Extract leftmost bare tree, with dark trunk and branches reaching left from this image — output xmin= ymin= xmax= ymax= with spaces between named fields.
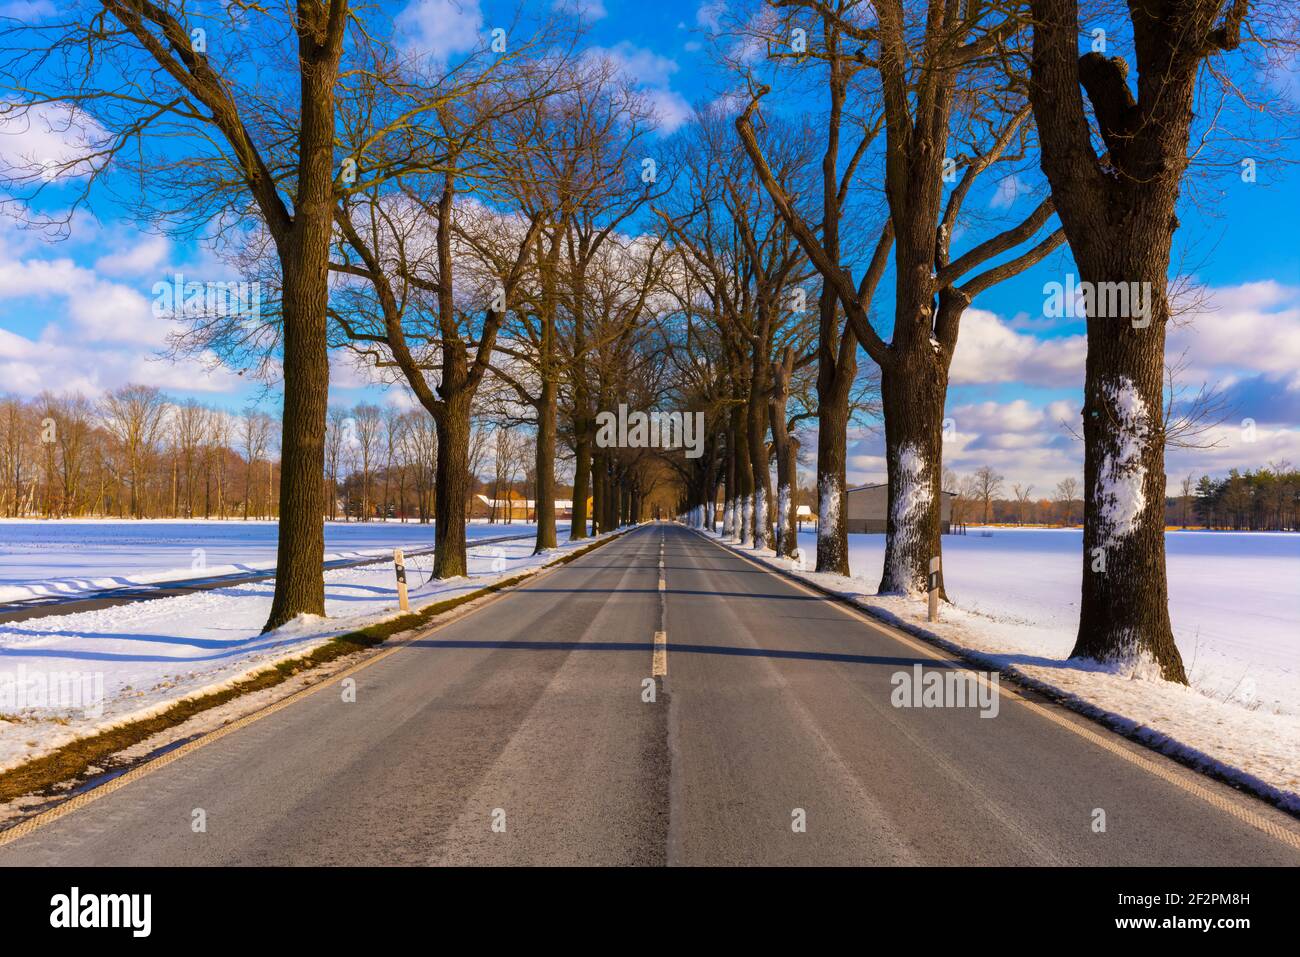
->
xmin=0 ymin=0 xmax=373 ymax=629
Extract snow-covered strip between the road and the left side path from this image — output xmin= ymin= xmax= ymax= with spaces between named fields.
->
xmin=0 ymin=523 xmax=588 ymax=770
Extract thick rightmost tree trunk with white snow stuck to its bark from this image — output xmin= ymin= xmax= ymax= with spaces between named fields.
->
xmin=1030 ymin=0 xmax=1216 ymax=684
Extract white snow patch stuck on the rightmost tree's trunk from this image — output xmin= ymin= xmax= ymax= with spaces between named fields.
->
xmin=1095 ymin=376 xmax=1151 ymax=547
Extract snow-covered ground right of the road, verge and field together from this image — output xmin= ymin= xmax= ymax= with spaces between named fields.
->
xmin=728 ymin=528 xmax=1300 ymax=810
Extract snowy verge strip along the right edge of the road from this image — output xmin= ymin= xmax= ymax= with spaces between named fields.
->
xmin=696 ymin=529 xmax=1300 ymax=814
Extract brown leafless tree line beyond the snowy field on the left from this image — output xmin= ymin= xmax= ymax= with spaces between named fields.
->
xmin=0 ymin=385 xmax=572 ymax=523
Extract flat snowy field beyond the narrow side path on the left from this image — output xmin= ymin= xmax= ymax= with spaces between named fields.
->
xmin=0 ymin=520 xmax=556 ymax=602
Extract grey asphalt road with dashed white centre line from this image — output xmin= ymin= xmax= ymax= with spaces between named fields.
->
xmin=0 ymin=524 xmax=1300 ymax=866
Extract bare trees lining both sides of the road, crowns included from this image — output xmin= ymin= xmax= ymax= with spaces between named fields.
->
xmin=0 ymin=0 xmax=1296 ymax=681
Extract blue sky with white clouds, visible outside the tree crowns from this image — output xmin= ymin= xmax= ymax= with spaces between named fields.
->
xmin=0 ymin=0 xmax=1300 ymax=494
